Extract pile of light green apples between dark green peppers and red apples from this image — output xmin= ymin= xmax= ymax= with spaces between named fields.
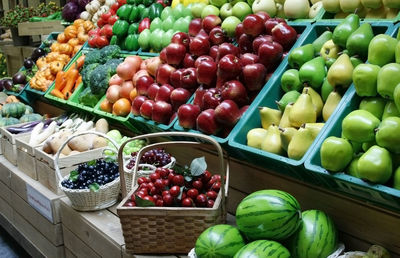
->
xmin=138 ymin=4 xmax=192 ymax=52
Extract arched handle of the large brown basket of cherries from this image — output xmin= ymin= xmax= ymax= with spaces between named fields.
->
xmin=118 ymin=132 xmax=229 ymax=203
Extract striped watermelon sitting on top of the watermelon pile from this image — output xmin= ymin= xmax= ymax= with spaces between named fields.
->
xmin=236 ymin=190 xmax=301 ymax=240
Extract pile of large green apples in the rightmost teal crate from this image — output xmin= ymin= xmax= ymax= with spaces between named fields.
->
xmin=320 ymin=28 xmax=400 ymax=189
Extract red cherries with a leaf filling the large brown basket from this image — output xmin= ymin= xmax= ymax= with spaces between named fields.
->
xmin=124 ymin=155 xmax=222 ymax=208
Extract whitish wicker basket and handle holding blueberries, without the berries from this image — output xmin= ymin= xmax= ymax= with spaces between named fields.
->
xmin=55 ymin=131 xmax=120 ymax=211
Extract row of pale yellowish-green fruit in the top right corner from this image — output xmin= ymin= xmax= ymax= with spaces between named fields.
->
xmin=322 ymin=0 xmax=400 ymax=19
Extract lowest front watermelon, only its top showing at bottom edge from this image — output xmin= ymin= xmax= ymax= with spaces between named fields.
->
xmin=234 ymin=240 xmax=290 ymax=258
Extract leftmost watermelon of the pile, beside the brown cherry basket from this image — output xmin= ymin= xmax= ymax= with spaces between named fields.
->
xmin=195 ymin=224 xmax=245 ymax=258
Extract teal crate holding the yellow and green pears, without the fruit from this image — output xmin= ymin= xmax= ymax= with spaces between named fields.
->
xmin=229 ymin=23 xmax=392 ymax=184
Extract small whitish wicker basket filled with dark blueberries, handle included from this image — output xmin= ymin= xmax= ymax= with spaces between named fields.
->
xmin=55 ymin=131 xmax=120 ymax=211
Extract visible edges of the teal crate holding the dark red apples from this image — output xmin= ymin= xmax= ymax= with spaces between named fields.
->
xmin=174 ymin=23 xmax=311 ymax=147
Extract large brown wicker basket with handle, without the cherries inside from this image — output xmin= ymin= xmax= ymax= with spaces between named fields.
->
xmin=117 ymin=132 xmax=229 ymax=254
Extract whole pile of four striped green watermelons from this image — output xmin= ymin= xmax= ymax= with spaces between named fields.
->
xmin=194 ymin=190 xmax=338 ymax=258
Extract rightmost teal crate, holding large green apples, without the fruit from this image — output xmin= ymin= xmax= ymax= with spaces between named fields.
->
xmin=305 ymin=86 xmax=400 ymax=211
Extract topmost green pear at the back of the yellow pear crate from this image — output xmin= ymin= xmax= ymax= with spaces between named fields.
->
xmin=332 ymin=13 xmax=360 ymax=48
